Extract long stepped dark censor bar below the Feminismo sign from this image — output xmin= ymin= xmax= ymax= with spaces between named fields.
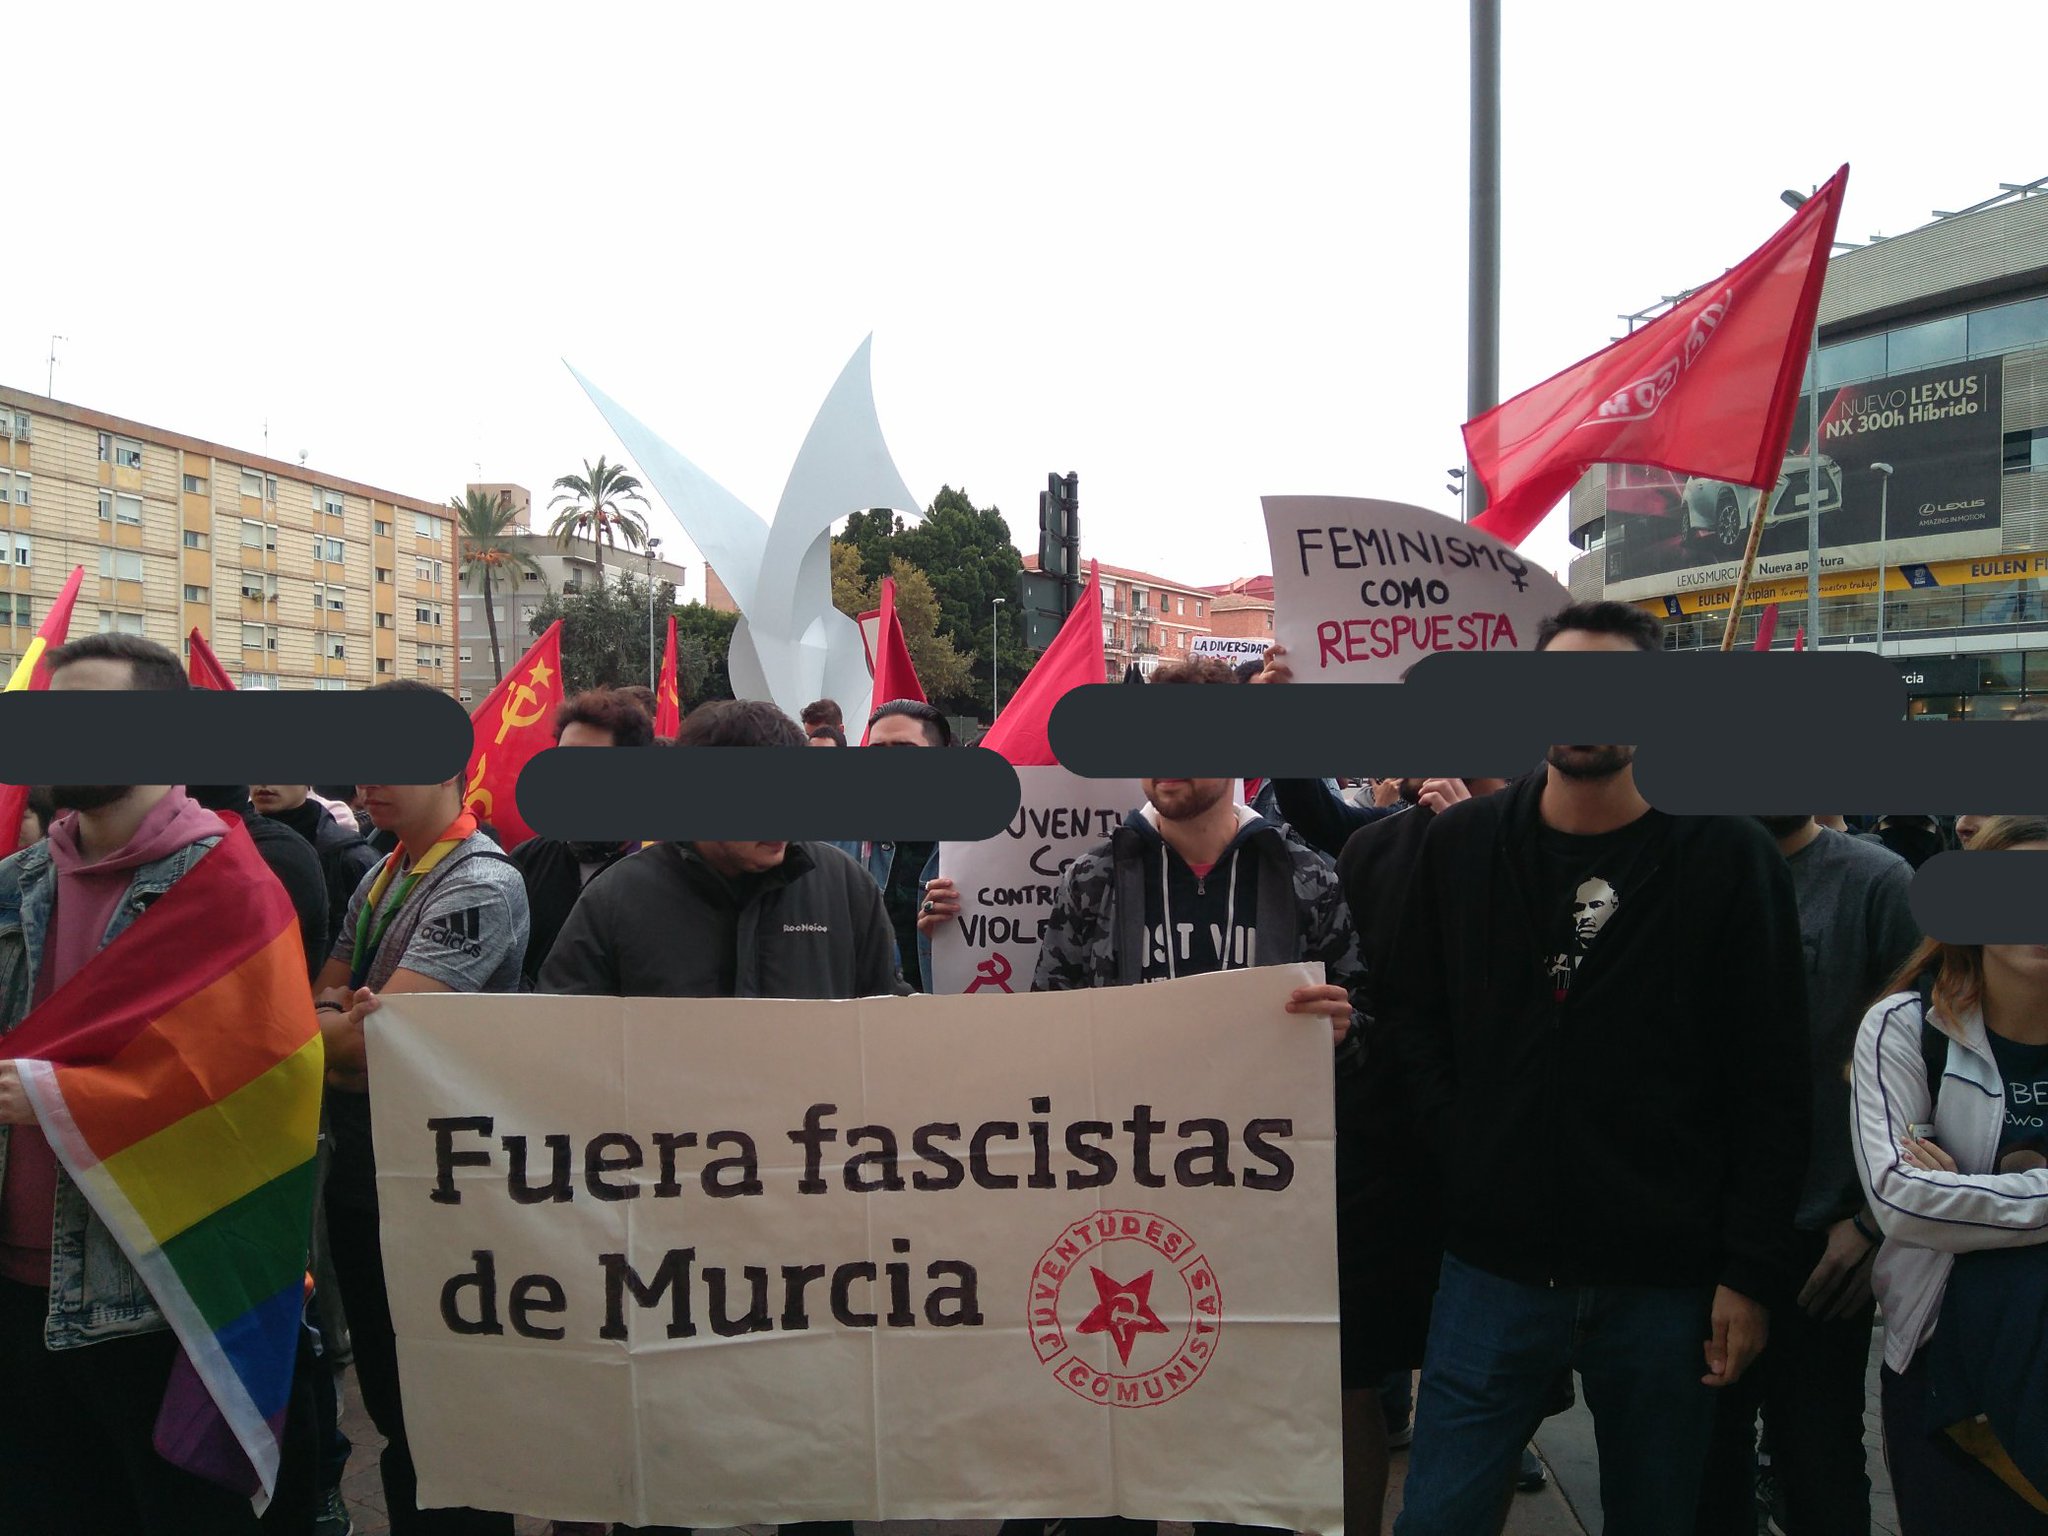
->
xmin=1051 ymin=651 xmax=2048 ymax=815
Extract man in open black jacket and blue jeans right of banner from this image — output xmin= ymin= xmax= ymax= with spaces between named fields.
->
xmin=1376 ymin=602 xmax=1812 ymax=1536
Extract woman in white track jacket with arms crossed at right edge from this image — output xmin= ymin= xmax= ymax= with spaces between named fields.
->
xmin=1851 ymin=817 xmax=2048 ymax=1536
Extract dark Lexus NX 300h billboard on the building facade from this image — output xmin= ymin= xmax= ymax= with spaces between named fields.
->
xmin=1606 ymin=358 xmax=2001 ymax=600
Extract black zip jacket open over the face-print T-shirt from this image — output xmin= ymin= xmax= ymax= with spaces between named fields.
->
xmin=1376 ymin=774 xmax=1810 ymax=1305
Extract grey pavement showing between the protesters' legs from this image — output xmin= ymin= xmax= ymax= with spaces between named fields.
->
xmin=342 ymin=1335 xmax=1898 ymax=1536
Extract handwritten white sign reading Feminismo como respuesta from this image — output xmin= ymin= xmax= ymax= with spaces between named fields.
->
xmin=1264 ymin=496 xmax=1571 ymax=682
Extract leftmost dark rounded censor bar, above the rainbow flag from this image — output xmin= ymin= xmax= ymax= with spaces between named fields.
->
xmin=0 ymin=688 xmax=473 ymax=784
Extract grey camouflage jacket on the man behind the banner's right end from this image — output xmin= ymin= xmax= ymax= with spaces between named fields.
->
xmin=1032 ymin=807 xmax=1364 ymax=1061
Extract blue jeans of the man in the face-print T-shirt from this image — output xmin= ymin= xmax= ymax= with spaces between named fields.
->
xmin=1395 ymin=1253 xmax=1714 ymax=1536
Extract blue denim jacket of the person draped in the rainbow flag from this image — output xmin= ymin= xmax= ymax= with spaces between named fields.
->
xmin=0 ymin=838 xmax=219 ymax=1350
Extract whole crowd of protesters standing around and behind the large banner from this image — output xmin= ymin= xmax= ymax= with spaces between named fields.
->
xmin=0 ymin=604 xmax=2048 ymax=1536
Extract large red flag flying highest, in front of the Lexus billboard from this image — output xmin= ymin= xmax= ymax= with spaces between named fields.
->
xmin=1464 ymin=166 xmax=1849 ymax=545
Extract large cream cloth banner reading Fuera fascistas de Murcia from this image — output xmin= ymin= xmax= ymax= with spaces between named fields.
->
xmin=369 ymin=965 xmax=1343 ymax=1532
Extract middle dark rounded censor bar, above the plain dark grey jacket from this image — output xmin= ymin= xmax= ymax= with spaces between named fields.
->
xmin=518 ymin=745 xmax=1019 ymax=842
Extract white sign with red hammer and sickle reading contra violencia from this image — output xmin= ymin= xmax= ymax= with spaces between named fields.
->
xmin=932 ymin=768 xmax=1145 ymax=993
